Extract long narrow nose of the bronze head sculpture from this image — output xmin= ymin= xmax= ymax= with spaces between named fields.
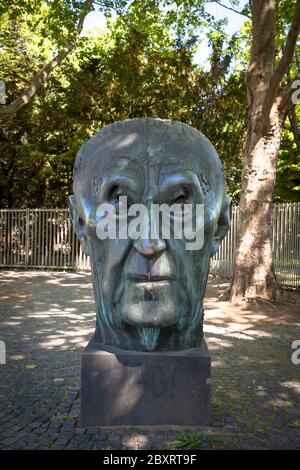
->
xmin=133 ymin=203 xmax=166 ymax=258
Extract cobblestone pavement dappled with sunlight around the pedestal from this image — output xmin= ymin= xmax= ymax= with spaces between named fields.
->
xmin=0 ymin=271 xmax=300 ymax=449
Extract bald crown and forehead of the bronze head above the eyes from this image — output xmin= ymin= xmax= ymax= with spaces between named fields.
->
xmin=74 ymin=118 xmax=226 ymax=212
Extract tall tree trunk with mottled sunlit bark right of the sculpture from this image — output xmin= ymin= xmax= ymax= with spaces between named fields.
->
xmin=229 ymin=0 xmax=300 ymax=302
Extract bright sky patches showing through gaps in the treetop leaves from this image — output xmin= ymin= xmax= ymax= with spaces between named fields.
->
xmin=83 ymin=0 xmax=247 ymax=67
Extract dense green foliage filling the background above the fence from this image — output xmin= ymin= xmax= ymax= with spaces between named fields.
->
xmin=0 ymin=0 xmax=300 ymax=207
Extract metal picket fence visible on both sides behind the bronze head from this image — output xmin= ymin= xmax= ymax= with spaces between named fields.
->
xmin=0 ymin=203 xmax=300 ymax=286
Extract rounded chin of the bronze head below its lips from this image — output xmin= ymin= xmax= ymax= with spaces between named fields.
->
xmin=121 ymin=281 xmax=176 ymax=328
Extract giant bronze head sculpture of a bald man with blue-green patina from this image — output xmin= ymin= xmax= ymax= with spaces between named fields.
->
xmin=71 ymin=119 xmax=230 ymax=350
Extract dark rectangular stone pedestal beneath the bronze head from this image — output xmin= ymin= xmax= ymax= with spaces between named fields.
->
xmin=81 ymin=339 xmax=211 ymax=427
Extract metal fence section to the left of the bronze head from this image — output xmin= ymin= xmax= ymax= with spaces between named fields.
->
xmin=0 ymin=209 xmax=89 ymax=270
